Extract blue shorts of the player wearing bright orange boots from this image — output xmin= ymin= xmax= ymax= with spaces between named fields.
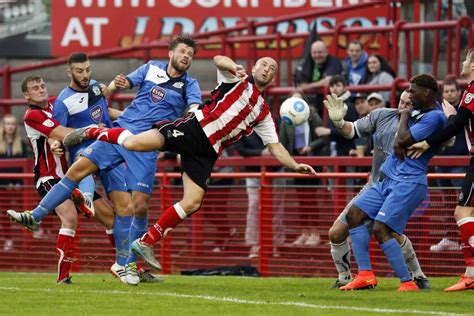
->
xmin=354 ymin=178 xmax=428 ymax=235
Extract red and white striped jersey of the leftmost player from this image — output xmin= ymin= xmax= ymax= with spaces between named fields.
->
xmin=23 ymin=104 xmax=67 ymax=186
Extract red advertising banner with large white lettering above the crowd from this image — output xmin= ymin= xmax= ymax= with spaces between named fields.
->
xmin=51 ymin=0 xmax=386 ymax=57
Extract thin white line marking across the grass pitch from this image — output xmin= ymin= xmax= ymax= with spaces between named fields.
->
xmin=0 ymin=286 xmax=467 ymax=316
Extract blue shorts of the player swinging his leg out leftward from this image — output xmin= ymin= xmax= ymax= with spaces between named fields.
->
xmin=82 ymin=141 xmax=158 ymax=194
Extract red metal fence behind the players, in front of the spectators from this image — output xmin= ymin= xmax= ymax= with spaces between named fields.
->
xmin=0 ymin=157 xmax=467 ymax=276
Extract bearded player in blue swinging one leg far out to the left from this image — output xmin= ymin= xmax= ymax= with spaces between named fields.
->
xmin=6 ymin=35 xmax=202 ymax=285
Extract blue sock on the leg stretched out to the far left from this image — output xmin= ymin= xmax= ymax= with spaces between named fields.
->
xmin=33 ymin=177 xmax=77 ymax=223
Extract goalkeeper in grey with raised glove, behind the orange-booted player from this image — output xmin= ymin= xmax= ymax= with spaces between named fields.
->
xmin=324 ymin=91 xmax=430 ymax=289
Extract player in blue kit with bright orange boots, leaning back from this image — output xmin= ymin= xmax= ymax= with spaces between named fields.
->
xmin=327 ymin=74 xmax=446 ymax=291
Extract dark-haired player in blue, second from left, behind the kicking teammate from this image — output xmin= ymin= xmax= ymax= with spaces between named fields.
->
xmin=53 ymin=52 xmax=141 ymax=282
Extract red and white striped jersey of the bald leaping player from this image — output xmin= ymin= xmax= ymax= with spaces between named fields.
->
xmin=195 ymin=71 xmax=279 ymax=155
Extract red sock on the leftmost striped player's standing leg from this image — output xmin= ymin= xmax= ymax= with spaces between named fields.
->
xmin=56 ymin=229 xmax=75 ymax=283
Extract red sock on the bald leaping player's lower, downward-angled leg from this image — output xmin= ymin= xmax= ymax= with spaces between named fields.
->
xmin=140 ymin=203 xmax=186 ymax=245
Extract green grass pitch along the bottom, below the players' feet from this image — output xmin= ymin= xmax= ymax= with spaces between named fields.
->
xmin=0 ymin=272 xmax=474 ymax=316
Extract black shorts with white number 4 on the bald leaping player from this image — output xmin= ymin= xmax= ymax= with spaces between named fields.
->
xmin=155 ymin=113 xmax=217 ymax=190
